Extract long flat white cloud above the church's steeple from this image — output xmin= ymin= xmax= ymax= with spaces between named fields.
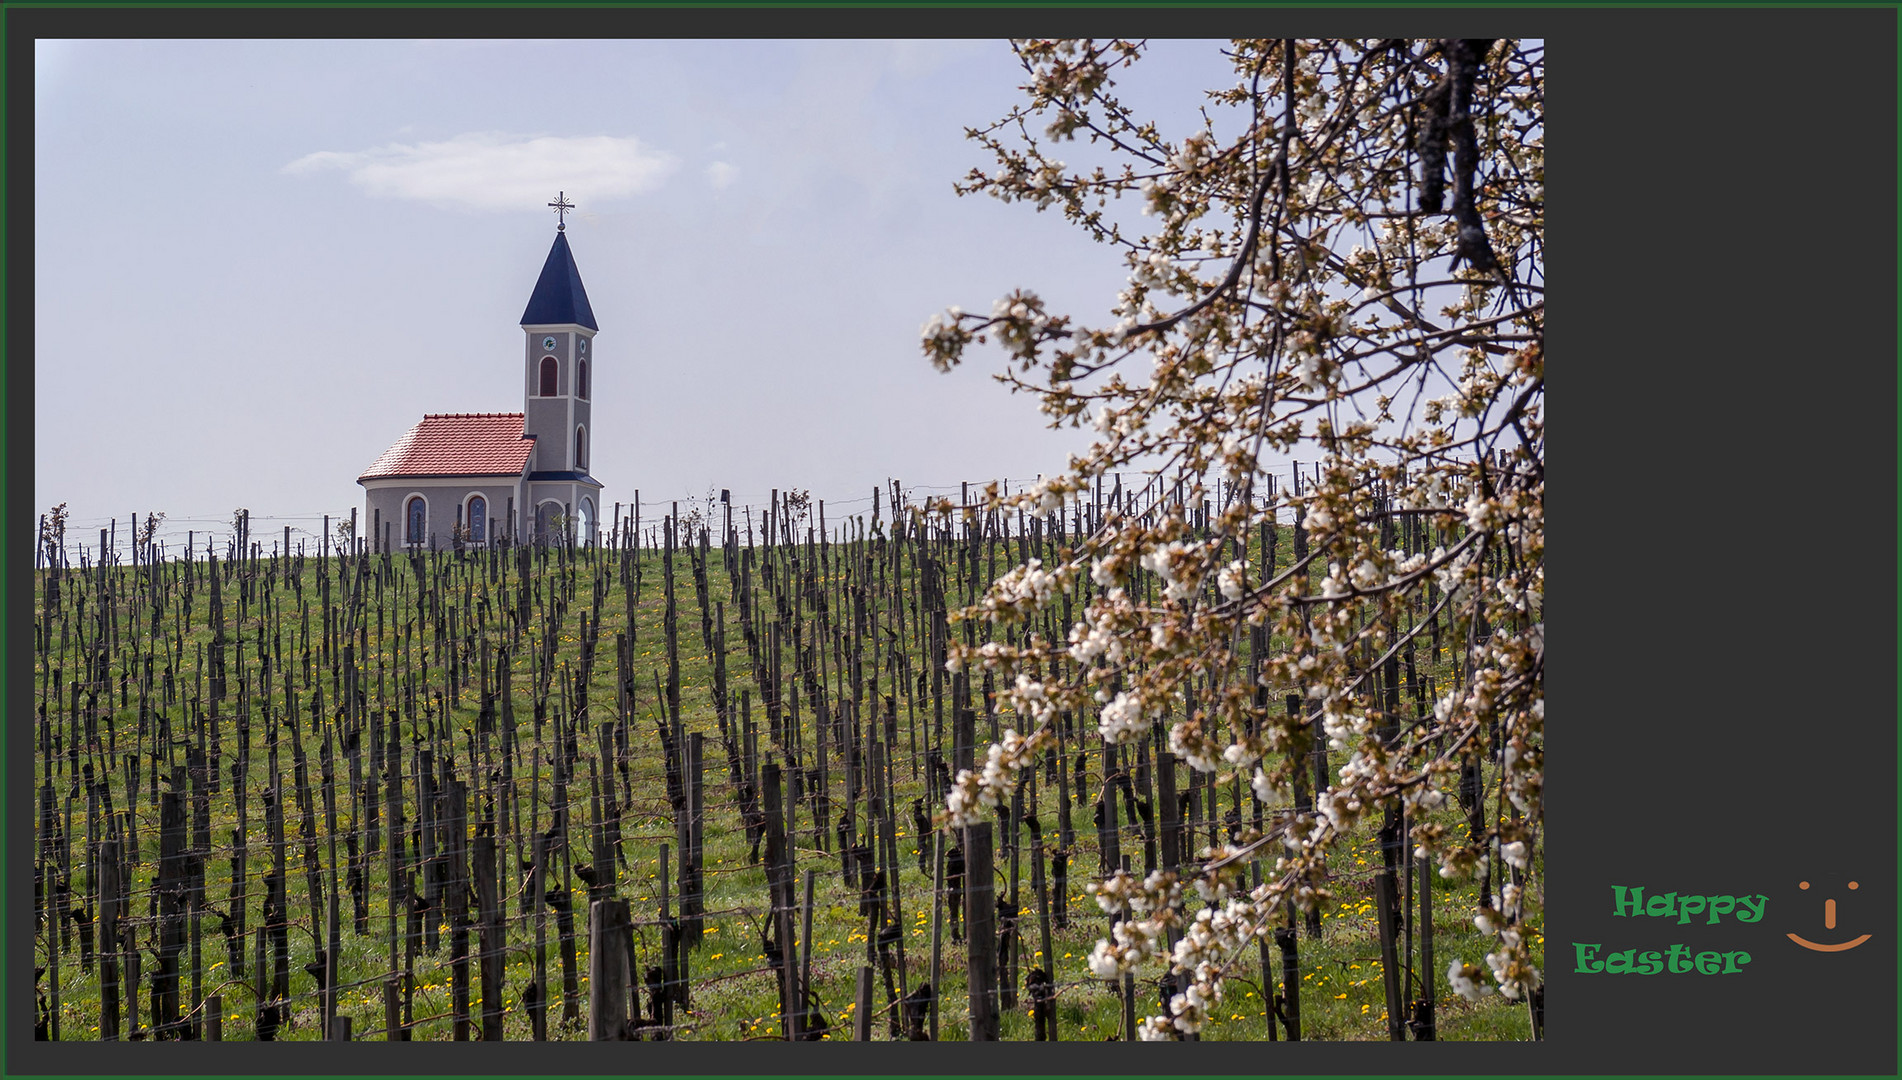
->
xmin=283 ymin=131 xmax=677 ymax=209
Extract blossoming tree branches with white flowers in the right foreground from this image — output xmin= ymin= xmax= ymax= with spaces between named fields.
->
xmin=922 ymin=38 xmax=1544 ymax=1038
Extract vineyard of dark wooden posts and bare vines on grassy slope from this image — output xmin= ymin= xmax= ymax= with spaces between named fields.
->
xmin=32 ymin=472 xmax=1543 ymax=1040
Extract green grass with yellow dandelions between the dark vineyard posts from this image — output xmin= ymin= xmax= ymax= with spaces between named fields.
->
xmin=34 ymin=517 xmax=1543 ymax=1040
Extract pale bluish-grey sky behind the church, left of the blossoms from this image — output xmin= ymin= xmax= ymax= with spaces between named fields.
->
xmin=34 ymin=40 xmax=1255 ymax=551
